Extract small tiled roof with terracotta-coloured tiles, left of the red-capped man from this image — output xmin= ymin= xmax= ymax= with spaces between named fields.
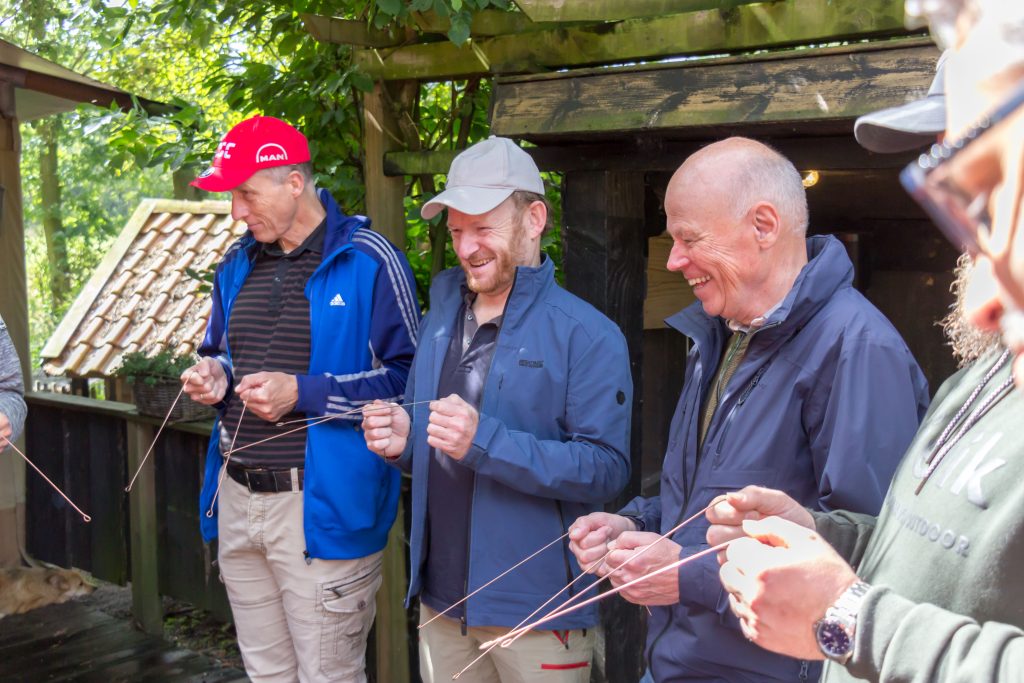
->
xmin=42 ymin=199 xmax=246 ymax=378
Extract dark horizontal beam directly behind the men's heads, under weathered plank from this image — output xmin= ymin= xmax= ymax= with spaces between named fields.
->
xmin=384 ymin=137 xmax=918 ymax=176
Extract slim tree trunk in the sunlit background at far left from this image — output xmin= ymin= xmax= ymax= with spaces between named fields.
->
xmin=36 ymin=116 xmax=71 ymax=311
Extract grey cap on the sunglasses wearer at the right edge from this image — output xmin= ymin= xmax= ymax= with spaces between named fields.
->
xmin=853 ymin=52 xmax=948 ymax=153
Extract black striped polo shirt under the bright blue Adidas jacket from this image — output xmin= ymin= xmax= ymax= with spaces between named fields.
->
xmin=221 ymin=219 xmax=327 ymax=469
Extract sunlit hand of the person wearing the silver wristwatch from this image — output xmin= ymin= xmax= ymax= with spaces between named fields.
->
xmin=719 ymin=517 xmax=857 ymax=659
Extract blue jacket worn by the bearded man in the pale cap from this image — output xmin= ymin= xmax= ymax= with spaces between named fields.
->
xmin=398 ymin=257 xmax=633 ymax=630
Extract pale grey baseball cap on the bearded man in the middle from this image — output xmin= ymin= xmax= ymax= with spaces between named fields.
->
xmin=420 ymin=135 xmax=544 ymax=220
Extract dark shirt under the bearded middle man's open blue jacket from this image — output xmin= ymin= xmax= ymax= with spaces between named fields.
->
xmin=421 ymin=288 xmax=503 ymax=618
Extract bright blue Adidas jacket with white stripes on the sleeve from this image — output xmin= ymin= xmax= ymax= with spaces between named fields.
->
xmin=200 ymin=189 xmax=420 ymax=559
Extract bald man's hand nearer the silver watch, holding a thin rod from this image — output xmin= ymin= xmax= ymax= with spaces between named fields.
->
xmin=599 ymin=531 xmax=682 ymax=605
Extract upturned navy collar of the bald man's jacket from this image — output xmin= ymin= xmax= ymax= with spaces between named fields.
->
xmin=665 ymin=234 xmax=853 ymax=354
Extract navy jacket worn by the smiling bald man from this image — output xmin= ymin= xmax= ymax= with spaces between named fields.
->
xmin=623 ymin=237 xmax=928 ymax=683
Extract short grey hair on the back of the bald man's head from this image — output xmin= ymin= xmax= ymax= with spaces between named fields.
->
xmin=733 ymin=142 xmax=809 ymax=237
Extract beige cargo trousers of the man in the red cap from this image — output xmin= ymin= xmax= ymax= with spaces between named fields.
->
xmin=217 ymin=476 xmax=381 ymax=683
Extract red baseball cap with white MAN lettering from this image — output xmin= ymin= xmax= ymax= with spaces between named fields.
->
xmin=191 ymin=116 xmax=309 ymax=193
